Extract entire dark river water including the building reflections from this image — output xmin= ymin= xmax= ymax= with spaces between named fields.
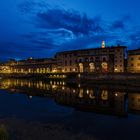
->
xmin=0 ymin=79 xmax=140 ymax=140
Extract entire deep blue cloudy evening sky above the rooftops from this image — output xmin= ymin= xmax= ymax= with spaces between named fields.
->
xmin=0 ymin=0 xmax=140 ymax=60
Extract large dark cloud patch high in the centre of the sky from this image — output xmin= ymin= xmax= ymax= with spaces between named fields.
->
xmin=37 ymin=9 xmax=103 ymax=35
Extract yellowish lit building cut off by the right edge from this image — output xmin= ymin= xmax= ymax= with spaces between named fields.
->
xmin=128 ymin=49 xmax=140 ymax=73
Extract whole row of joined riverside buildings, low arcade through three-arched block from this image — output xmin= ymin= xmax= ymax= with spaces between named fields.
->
xmin=0 ymin=41 xmax=126 ymax=74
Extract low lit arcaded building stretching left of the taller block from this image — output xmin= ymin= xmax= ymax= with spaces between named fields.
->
xmin=0 ymin=58 xmax=57 ymax=74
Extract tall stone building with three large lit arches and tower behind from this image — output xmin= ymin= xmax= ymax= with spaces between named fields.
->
xmin=55 ymin=42 xmax=126 ymax=72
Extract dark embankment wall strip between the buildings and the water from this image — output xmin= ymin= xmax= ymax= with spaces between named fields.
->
xmin=0 ymin=73 xmax=140 ymax=87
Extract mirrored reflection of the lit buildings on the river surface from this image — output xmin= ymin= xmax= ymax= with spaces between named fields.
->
xmin=0 ymin=79 xmax=140 ymax=116
